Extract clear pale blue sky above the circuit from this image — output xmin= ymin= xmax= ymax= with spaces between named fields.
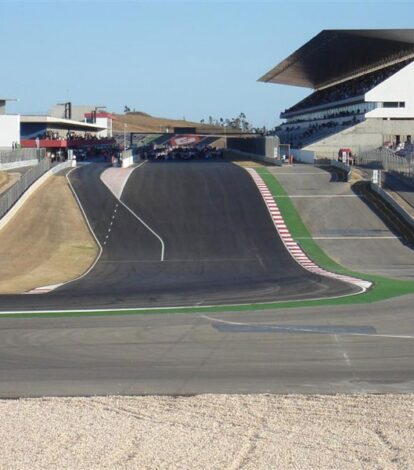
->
xmin=0 ymin=0 xmax=414 ymax=128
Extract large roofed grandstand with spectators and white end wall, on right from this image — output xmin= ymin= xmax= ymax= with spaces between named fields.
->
xmin=259 ymin=29 xmax=414 ymax=158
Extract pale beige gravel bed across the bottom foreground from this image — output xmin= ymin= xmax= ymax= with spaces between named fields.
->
xmin=0 ymin=395 xmax=414 ymax=470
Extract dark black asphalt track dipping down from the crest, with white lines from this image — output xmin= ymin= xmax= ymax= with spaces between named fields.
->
xmin=1 ymin=162 xmax=357 ymax=311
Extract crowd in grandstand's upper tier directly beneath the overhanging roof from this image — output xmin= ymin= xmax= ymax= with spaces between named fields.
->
xmin=282 ymin=59 xmax=412 ymax=116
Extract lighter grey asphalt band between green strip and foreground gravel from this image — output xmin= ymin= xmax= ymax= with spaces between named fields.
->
xmin=0 ymin=296 xmax=414 ymax=398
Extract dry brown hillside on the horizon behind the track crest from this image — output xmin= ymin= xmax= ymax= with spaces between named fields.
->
xmin=112 ymin=112 xmax=230 ymax=134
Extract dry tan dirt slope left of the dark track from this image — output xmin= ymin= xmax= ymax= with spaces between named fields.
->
xmin=0 ymin=172 xmax=98 ymax=294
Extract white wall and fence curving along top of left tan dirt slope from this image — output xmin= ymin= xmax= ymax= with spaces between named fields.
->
xmin=0 ymin=160 xmax=72 ymax=230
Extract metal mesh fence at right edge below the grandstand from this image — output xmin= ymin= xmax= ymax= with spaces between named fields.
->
xmin=358 ymin=148 xmax=414 ymax=179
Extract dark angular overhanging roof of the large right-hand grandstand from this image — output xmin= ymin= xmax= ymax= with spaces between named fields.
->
xmin=259 ymin=29 xmax=414 ymax=89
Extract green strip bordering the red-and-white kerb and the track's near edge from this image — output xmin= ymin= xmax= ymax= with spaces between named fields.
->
xmin=4 ymin=167 xmax=414 ymax=318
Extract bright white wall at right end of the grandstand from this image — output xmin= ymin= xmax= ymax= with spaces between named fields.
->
xmin=365 ymin=62 xmax=414 ymax=118
